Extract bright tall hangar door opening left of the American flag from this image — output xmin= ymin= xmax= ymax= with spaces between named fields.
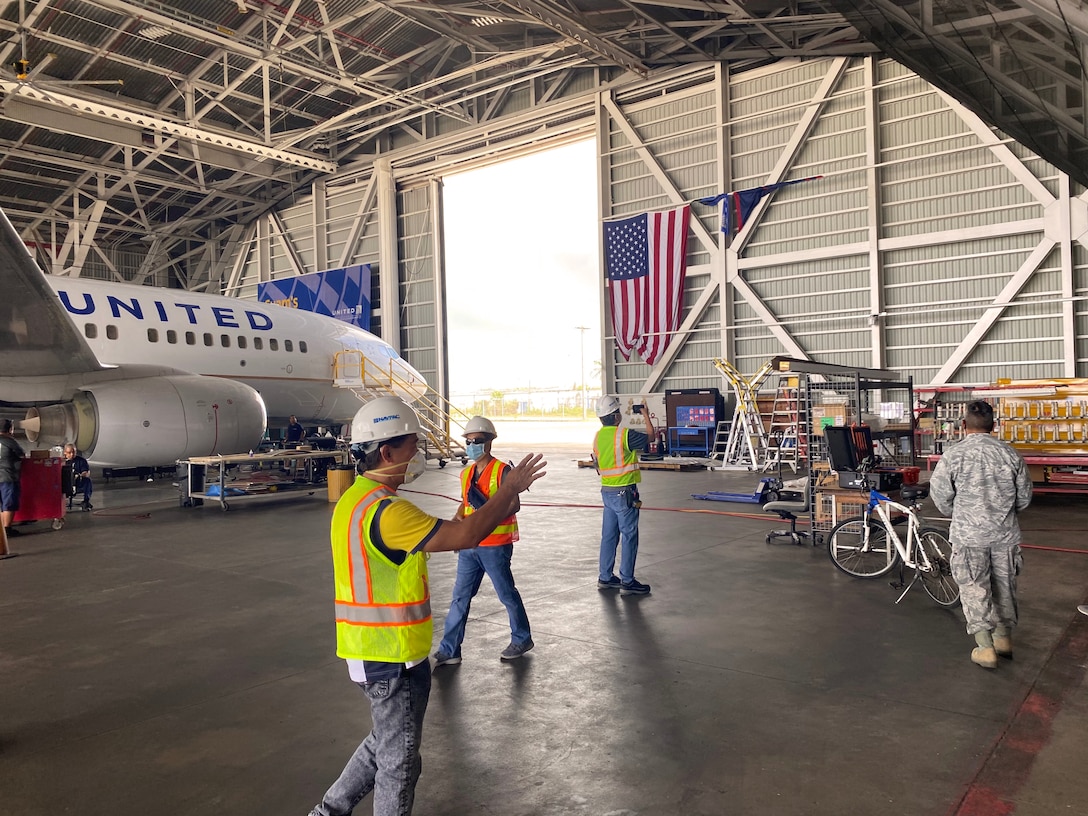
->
xmin=443 ymin=139 xmax=602 ymax=428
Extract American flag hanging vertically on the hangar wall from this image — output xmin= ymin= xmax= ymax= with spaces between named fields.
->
xmin=605 ymin=206 xmax=691 ymax=366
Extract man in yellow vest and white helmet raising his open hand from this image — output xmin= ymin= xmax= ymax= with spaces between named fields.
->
xmin=310 ymin=397 xmax=547 ymax=816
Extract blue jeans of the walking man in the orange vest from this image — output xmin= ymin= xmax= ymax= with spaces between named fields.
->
xmin=438 ymin=544 xmax=530 ymax=657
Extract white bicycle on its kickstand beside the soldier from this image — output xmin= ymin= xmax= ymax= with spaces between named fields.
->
xmin=827 ymin=485 xmax=960 ymax=606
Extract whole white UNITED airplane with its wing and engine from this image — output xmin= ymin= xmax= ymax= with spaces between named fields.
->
xmin=0 ymin=207 xmax=426 ymax=467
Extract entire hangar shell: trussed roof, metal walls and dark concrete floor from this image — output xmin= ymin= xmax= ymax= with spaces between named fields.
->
xmin=6 ymin=0 xmax=1088 ymax=816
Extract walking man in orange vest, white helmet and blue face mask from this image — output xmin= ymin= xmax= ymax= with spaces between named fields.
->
xmin=434 ymin=417 xmax=533 ymax=668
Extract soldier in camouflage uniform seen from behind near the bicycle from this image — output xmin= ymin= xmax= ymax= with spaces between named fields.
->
xmin=929 ymin=400 xmax=1031 ymax=669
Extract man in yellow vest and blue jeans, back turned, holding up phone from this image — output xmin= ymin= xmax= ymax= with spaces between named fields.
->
xmin=593 ymin=394 xmax=654 ymax=595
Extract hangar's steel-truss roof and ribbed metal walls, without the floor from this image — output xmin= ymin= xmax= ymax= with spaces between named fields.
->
xmin=6 ymin=0 xmax=1088 ymax=394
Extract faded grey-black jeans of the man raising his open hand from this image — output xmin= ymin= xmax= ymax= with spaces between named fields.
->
xmin=310 ymin=660 xmax=431 ymax=816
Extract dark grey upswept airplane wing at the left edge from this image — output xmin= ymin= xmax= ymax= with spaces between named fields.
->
xmin=0 ymin=212 xmax=102 ymax=376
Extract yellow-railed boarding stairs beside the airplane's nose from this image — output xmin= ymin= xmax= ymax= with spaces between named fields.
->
xmin=333 ymin=349 xmax=469 ymax=468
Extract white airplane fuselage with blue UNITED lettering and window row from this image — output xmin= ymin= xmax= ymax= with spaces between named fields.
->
xmin=47 ymin=275 xmax=426 ymax=423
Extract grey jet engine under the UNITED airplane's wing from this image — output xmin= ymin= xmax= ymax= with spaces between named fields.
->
xmin=22 ymin=374 xmax=267 ymax=467
